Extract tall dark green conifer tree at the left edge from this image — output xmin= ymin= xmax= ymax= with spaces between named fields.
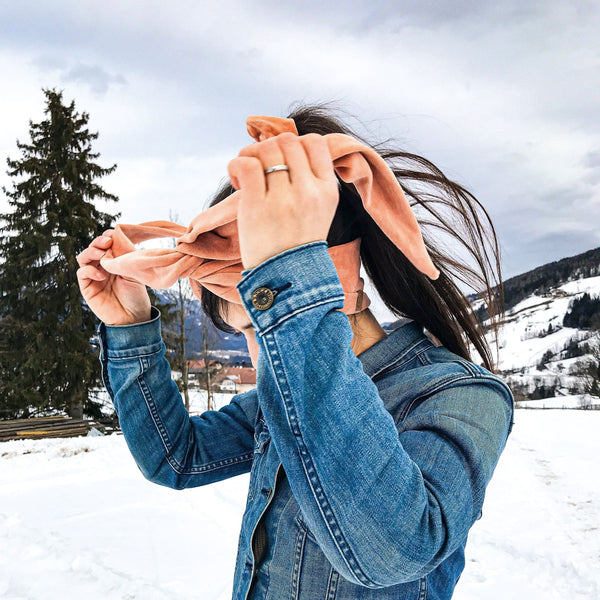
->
xmin=0 ymin=89 xmax=120 ymax=418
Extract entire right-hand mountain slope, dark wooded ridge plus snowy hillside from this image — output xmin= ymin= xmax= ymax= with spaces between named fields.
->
xmin=488 ymin=248 xmax=600 ymax=408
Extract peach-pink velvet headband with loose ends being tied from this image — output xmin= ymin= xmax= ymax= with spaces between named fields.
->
xmin=100 ymin=116 xmax=439 ymax=314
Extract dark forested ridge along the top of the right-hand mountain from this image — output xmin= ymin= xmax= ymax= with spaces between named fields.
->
xmin=469 ymin=248 xmax=600 ymax=321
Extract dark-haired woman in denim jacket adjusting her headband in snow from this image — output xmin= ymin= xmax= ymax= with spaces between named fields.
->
xmin=78 ymin=106 xmax=513 ymax=600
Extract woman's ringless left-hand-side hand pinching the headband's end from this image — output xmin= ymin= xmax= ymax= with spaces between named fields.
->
xmin=77 ymin=229 xmax=151 ymax=325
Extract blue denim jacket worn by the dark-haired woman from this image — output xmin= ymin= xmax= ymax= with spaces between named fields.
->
xmin=99 ymin=241 xmax=514 ymax=600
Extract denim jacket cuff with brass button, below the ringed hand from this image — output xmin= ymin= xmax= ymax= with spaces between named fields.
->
xmin=236 ymin=240 xmax=344 ymax=335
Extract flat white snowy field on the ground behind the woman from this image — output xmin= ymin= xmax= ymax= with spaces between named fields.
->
xmin=0 ymin=410 xmax=600 ymax=600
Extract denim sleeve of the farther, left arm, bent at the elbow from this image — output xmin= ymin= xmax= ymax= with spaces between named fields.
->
xmin=98 ymin=307 xmax=258 ymax=489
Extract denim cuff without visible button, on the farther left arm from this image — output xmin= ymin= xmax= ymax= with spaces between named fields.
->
xmin=100 ymin=306 xmax=162 ymax=356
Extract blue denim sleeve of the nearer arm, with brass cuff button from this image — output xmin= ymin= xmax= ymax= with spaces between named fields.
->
xmin=237 ymin=241 xmax=512 ymax=588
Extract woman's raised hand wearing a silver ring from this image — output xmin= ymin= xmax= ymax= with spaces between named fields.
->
xmin=228 ymin=132 xmax=339 ymax=269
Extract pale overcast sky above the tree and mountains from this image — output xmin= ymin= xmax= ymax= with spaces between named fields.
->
xmin=0 ymin=0 xmax=600 ymax=324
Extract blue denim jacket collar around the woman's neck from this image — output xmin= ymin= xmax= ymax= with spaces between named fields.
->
xmin=357 ymin=318 xmax=429 ymax=378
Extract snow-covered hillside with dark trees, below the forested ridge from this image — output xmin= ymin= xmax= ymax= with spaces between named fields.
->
xmin=490 ymin=277 xmax=600 ymax=408
